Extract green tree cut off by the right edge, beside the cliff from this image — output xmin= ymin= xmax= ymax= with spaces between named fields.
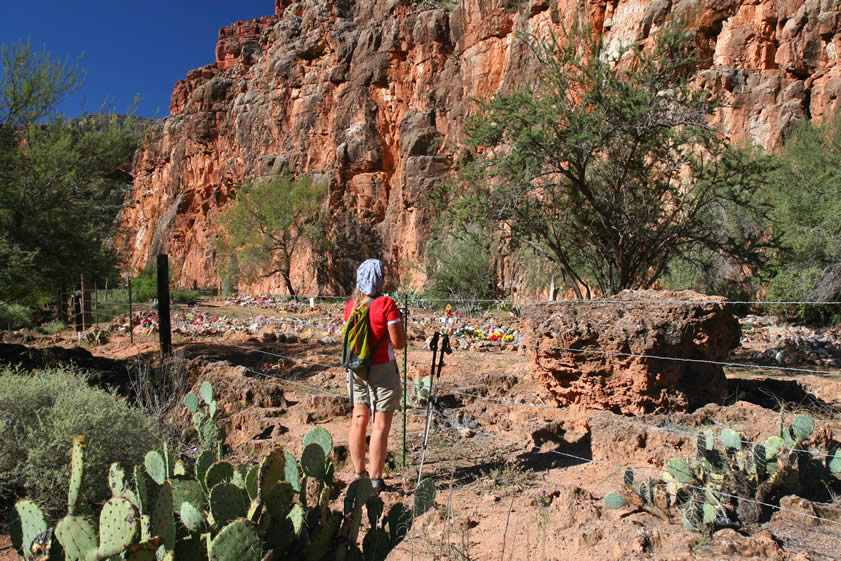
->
xmin=770 ymin=113 xmax=841 ymax=315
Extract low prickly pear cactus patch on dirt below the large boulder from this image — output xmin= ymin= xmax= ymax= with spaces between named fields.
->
xmin=604 ymin=411 xmax=841 ymax=534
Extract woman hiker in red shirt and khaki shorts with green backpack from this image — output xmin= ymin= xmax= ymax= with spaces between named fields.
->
xmin=345 ymin=259 xmax=406 ymax=493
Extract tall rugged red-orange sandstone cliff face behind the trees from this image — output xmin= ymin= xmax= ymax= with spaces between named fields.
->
xmin=119 ymin=0 xmax=841 ymax=293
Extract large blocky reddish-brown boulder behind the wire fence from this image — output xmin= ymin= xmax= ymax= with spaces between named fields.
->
xmin=523 ymin=290 xmax=740 ymax=415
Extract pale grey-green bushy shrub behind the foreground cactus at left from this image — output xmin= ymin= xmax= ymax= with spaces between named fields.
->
xmin=0 ymin=367 xmax=158 ymax=514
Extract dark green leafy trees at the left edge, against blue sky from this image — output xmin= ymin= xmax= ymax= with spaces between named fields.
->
xmin=0 ymin=44 xmax=138 ymax=303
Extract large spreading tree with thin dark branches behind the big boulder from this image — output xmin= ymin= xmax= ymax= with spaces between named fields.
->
xmin=449 ymin=18 xmax=768 ymax=297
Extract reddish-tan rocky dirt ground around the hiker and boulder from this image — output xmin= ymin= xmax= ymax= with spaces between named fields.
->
xmin=0 ymin=302 xmax=841 ymax=561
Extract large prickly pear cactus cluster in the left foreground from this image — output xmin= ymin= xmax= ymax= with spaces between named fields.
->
xmin=15 ymin=380 xmax=435 ymax=561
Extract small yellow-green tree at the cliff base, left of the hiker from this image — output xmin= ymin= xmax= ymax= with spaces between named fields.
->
xmin=221 ymin=176 xmax=327 ymax=297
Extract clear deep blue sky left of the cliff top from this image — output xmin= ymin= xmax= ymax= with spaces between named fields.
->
xmin=0 ymin=0 xmax=274 ymax=117
